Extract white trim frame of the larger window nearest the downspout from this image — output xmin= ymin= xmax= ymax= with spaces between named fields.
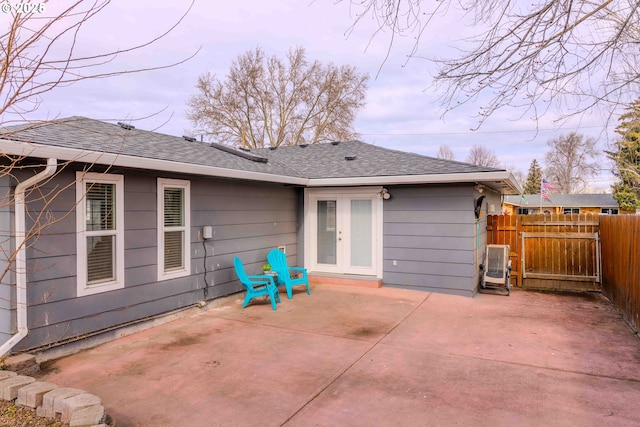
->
xmin=76 ymin=172 xmax=124 ymax=297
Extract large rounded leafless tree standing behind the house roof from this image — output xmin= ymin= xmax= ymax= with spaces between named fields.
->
xmin=188 ymin=47 xmax=369 ymax=148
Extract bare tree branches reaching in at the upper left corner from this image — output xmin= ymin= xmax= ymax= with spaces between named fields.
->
xmin=0 ymin=0 xmax=195 ymax=125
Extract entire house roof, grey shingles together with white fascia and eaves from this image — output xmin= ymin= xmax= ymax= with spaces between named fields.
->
xmin=0 ymin=117 xmax=520 ymax=194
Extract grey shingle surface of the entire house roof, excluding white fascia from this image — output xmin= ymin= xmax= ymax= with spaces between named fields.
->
xmin=0 ymin=117 xmax=504 ymax=186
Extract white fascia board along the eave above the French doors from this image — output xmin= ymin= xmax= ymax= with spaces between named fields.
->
xmin=308 ymin=171 xmax=521 ymax=194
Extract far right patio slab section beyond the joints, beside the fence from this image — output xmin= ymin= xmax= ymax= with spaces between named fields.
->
xmin=383 ymin=291 xmax=640 ymax=381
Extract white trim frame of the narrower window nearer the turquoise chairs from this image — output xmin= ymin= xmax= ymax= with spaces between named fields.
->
xmin=157 ymin=178 xmax=191 ymax=280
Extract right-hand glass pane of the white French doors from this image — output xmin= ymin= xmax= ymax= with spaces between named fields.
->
xmin=350 ymin=200 xmax=373 ymax=267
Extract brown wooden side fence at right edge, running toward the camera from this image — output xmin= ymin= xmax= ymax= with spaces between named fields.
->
xmin=600 ymin=215 xmax=640 ymax=331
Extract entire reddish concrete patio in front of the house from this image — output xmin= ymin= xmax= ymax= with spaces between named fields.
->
xmin=38 ymin=285 xmax=640 ymax=427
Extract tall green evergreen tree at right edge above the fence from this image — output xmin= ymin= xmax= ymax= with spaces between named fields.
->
xmin=606 ymin=99 xmax=640 ymax=211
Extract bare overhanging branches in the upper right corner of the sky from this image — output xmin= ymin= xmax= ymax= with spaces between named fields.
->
xmin=342 ymin=0 xmax=640 ymax=124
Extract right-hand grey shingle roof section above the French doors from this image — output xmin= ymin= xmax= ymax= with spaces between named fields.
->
xmin=252 ymin=141 xmax=502 ymax=178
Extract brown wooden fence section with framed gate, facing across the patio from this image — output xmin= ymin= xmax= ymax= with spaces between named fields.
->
xmin=487 ymin=214 xmax=601 ymax=290
